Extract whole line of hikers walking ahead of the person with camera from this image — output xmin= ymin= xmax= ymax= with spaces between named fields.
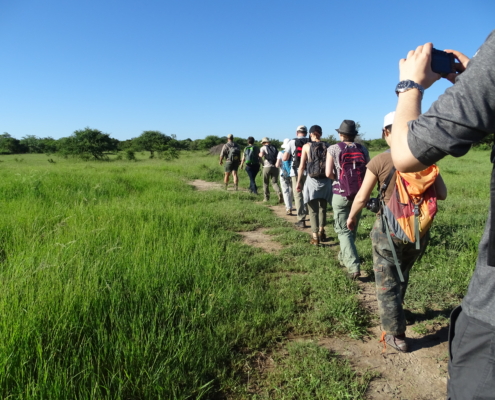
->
xmin=219 ymin=112 xmax=447 ymax=352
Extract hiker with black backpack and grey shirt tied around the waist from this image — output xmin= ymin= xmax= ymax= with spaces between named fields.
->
xmin=296 ymin=125 xmax=332 ymax=246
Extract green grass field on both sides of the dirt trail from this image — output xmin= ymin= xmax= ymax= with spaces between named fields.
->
xmin=0 ymin=151 xmax=491 ymax=399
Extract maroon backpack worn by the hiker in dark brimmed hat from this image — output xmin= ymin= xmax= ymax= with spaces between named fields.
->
xmin=337 ymin=142 xmax=367 ymax=200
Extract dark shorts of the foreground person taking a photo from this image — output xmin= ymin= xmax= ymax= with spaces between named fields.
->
xmin=447 ymin=307 xmax=495 ymax=400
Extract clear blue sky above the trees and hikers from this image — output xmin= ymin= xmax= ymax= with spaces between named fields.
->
xmin=0 ymin=0 xmax=495 ymax=140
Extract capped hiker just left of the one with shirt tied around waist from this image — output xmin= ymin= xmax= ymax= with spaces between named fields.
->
xmin=282 ymin=125 xmax=309 ymax=228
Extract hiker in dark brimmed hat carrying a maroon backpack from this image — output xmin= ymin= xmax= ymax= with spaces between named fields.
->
xmin=326 ymin=119 xmax=370 ymax=280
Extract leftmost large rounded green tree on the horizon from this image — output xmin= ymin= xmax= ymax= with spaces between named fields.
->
xmin=59 ymin=127 xmax=118 ymax=160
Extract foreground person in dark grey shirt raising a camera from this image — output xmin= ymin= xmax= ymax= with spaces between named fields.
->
xmin=390 ymin=31 xmax=495 ymax=400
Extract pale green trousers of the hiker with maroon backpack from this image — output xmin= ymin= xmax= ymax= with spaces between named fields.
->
xmin=332 ymin=194 xmax=361 ymax=273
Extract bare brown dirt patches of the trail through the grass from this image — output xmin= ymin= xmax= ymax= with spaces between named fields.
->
xmin=191 ymin=180 xmax=448 ymax=400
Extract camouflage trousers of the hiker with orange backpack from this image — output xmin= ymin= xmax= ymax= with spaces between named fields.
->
xmin=370 ymin=218 xmax=428 ymax=336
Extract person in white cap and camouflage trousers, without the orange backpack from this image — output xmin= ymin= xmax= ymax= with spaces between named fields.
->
xmin=347 ymin=112 xmax=447 ymax=352
